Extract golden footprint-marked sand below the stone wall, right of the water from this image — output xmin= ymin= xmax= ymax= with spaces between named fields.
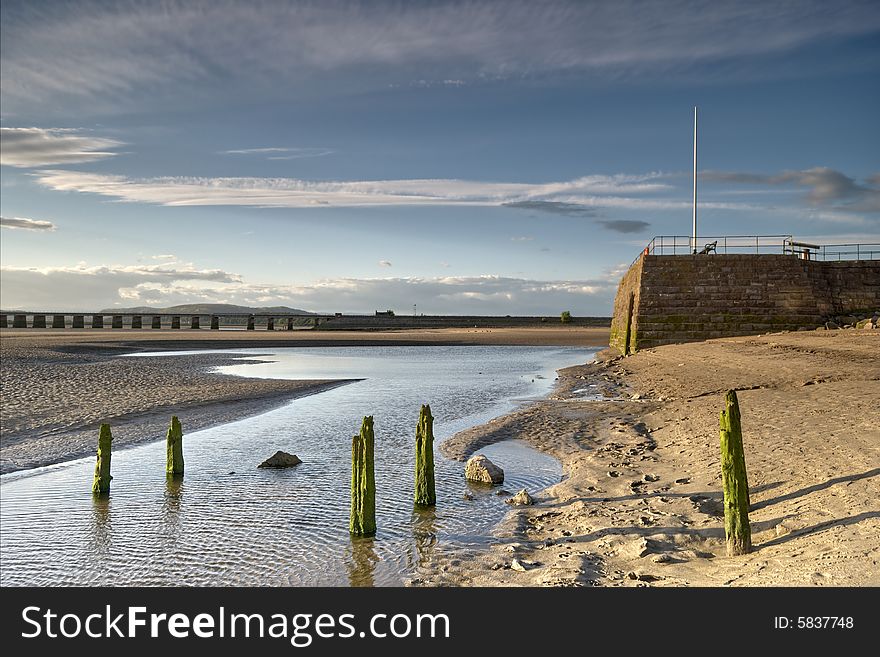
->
xmin=422 ymin=330 xmax=880 ymax=586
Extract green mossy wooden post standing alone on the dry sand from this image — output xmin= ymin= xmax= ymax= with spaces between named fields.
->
xmin=721 ymin=390 xmax=752 ymax=557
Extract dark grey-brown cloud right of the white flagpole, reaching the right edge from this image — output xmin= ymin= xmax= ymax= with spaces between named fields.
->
xmin=700 ymin=167 xmax=880 ymax=212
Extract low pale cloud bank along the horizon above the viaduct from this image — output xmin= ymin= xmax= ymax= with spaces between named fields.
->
xmin=0 ymin=263 xmax=622 ymax=315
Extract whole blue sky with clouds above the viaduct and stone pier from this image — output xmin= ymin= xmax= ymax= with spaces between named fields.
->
xmin=0 ymin=0 xmax=880 ymax=316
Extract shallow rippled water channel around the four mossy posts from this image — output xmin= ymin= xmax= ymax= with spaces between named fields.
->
xmin=0 ymin=346 xmax=594 ymax=586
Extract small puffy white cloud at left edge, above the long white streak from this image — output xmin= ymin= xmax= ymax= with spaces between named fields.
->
xmin=0 ymin=128 xmax=123 ymax=168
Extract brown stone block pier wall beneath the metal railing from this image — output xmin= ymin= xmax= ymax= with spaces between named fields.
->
xmin=611 ymin=255 xmax=880 ymax=353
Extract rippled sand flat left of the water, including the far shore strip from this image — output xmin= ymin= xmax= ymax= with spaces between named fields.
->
xmin=0 ymin=326 xmax=608 ymax=473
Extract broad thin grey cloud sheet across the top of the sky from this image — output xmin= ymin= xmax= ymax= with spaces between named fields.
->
xmin=2 ymin=0 xmax=880 ymax=111
